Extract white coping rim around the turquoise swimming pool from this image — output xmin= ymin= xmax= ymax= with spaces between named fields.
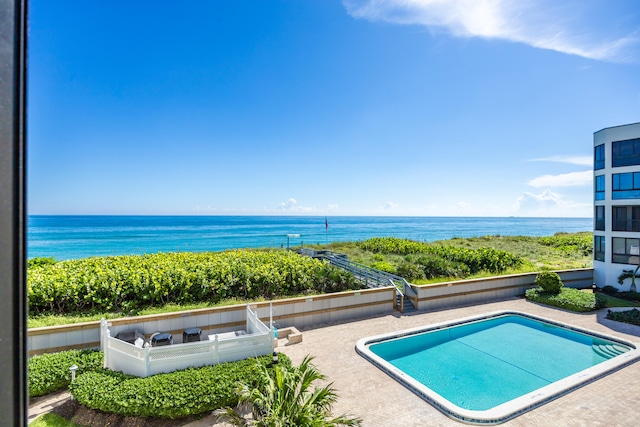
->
xmin=356 ymin=310 xmax=640 ymax=425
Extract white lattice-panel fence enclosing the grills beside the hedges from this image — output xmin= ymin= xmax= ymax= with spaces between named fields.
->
xmin=100 ymin=306 xmax=274 ymax=377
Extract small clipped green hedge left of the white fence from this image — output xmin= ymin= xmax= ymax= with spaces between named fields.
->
xmin=27 ymin=350 xmax=103 ymax=397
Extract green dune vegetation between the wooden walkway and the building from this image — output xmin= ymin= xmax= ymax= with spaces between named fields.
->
xmin=323 ymin=232 xmax=593 ymax=285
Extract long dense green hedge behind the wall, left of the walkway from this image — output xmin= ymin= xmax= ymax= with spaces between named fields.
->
xmin=27 ymin=250 xmax=360 ymax=314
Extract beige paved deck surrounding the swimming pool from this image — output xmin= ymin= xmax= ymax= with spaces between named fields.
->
xmin=278 ymin=298 xmax=640 ymax=427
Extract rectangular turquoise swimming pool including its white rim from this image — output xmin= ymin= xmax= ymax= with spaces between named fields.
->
xmin=356 ymin=312 xmax=640 ymax=424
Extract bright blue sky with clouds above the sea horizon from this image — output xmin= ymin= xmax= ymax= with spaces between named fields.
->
xmin=27 ymin=0 xmax=640 ymax=217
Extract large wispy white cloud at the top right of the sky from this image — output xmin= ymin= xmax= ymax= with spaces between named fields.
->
xmin=343 ymin=0 xmax=639 ymax=61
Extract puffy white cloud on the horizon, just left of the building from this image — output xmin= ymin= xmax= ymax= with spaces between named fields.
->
xmin=513 ymin=189 xmax=593 ymax=217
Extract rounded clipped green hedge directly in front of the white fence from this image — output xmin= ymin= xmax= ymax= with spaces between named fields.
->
xmin=69 ymin=353 xmax=291 ymax=419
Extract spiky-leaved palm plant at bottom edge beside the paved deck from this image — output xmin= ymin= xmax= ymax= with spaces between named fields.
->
xmin=219 ymin=356 xmax=362 ymax=427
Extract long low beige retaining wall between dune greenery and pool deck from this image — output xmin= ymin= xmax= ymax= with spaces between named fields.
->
xmin=27 ymin=268 xmax=593 ymax=355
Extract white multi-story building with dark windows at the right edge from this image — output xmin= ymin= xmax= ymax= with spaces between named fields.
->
xmin=593 ymin=123 xmax=640 ymax=290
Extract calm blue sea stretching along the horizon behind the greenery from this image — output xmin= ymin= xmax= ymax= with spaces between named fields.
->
xmin=27 ymin=215 xmax=593 ymax=260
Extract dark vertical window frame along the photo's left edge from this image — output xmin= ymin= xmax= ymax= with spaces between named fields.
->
xmin=0 ymin=0 xmax=27 ymax=426
